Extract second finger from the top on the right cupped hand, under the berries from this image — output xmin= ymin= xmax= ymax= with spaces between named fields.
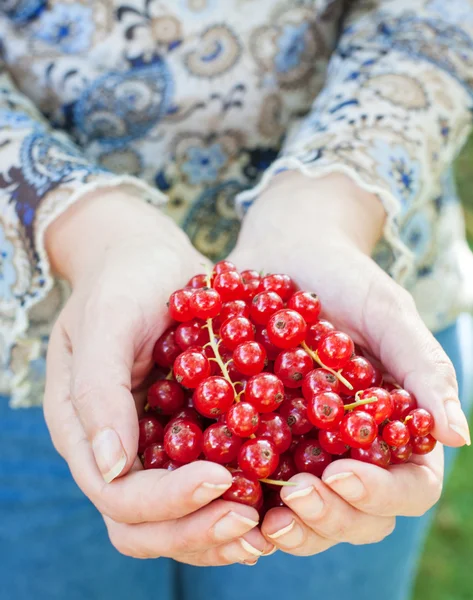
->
xmin=281 ymin=473 xmax=395 ymax=544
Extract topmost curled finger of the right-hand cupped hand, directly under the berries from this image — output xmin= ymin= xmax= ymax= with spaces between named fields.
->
xmin=322 ymin=444 xmax=443 ymax=517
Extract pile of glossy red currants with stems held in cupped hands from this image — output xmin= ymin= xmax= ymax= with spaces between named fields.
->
xmin=139 ymin=261 xmax=436 ymax=509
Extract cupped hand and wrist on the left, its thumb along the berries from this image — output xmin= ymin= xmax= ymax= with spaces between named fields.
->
xmin=44 ymin=190 xmax=273 ymax=565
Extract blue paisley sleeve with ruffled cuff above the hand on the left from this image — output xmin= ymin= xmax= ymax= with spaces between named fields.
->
xmin=0 ymin=61 xmax=164 ymax=381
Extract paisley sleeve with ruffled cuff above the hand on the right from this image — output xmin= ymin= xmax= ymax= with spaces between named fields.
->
xmin=237 ymin=0 xmax=473 ymax=282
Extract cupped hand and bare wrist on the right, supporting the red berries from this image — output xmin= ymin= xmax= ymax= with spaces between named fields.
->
xmin=229 ymin=173 xmax=470 ymax=555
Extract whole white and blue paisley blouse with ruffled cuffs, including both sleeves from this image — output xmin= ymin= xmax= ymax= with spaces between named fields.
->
xmin=0 ymin=0 xmax=473 ymax=406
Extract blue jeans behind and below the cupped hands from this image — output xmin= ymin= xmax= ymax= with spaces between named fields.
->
xmin=0 ymin=316 xmax=473 ymax=600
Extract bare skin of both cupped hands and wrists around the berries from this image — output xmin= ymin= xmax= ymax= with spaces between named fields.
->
xmin=45 ymin=173 xmax=469 ymax=565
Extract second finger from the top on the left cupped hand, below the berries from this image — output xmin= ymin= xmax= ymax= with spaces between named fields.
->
xmin=104 ymin=500 xmax=266 ymax=559
